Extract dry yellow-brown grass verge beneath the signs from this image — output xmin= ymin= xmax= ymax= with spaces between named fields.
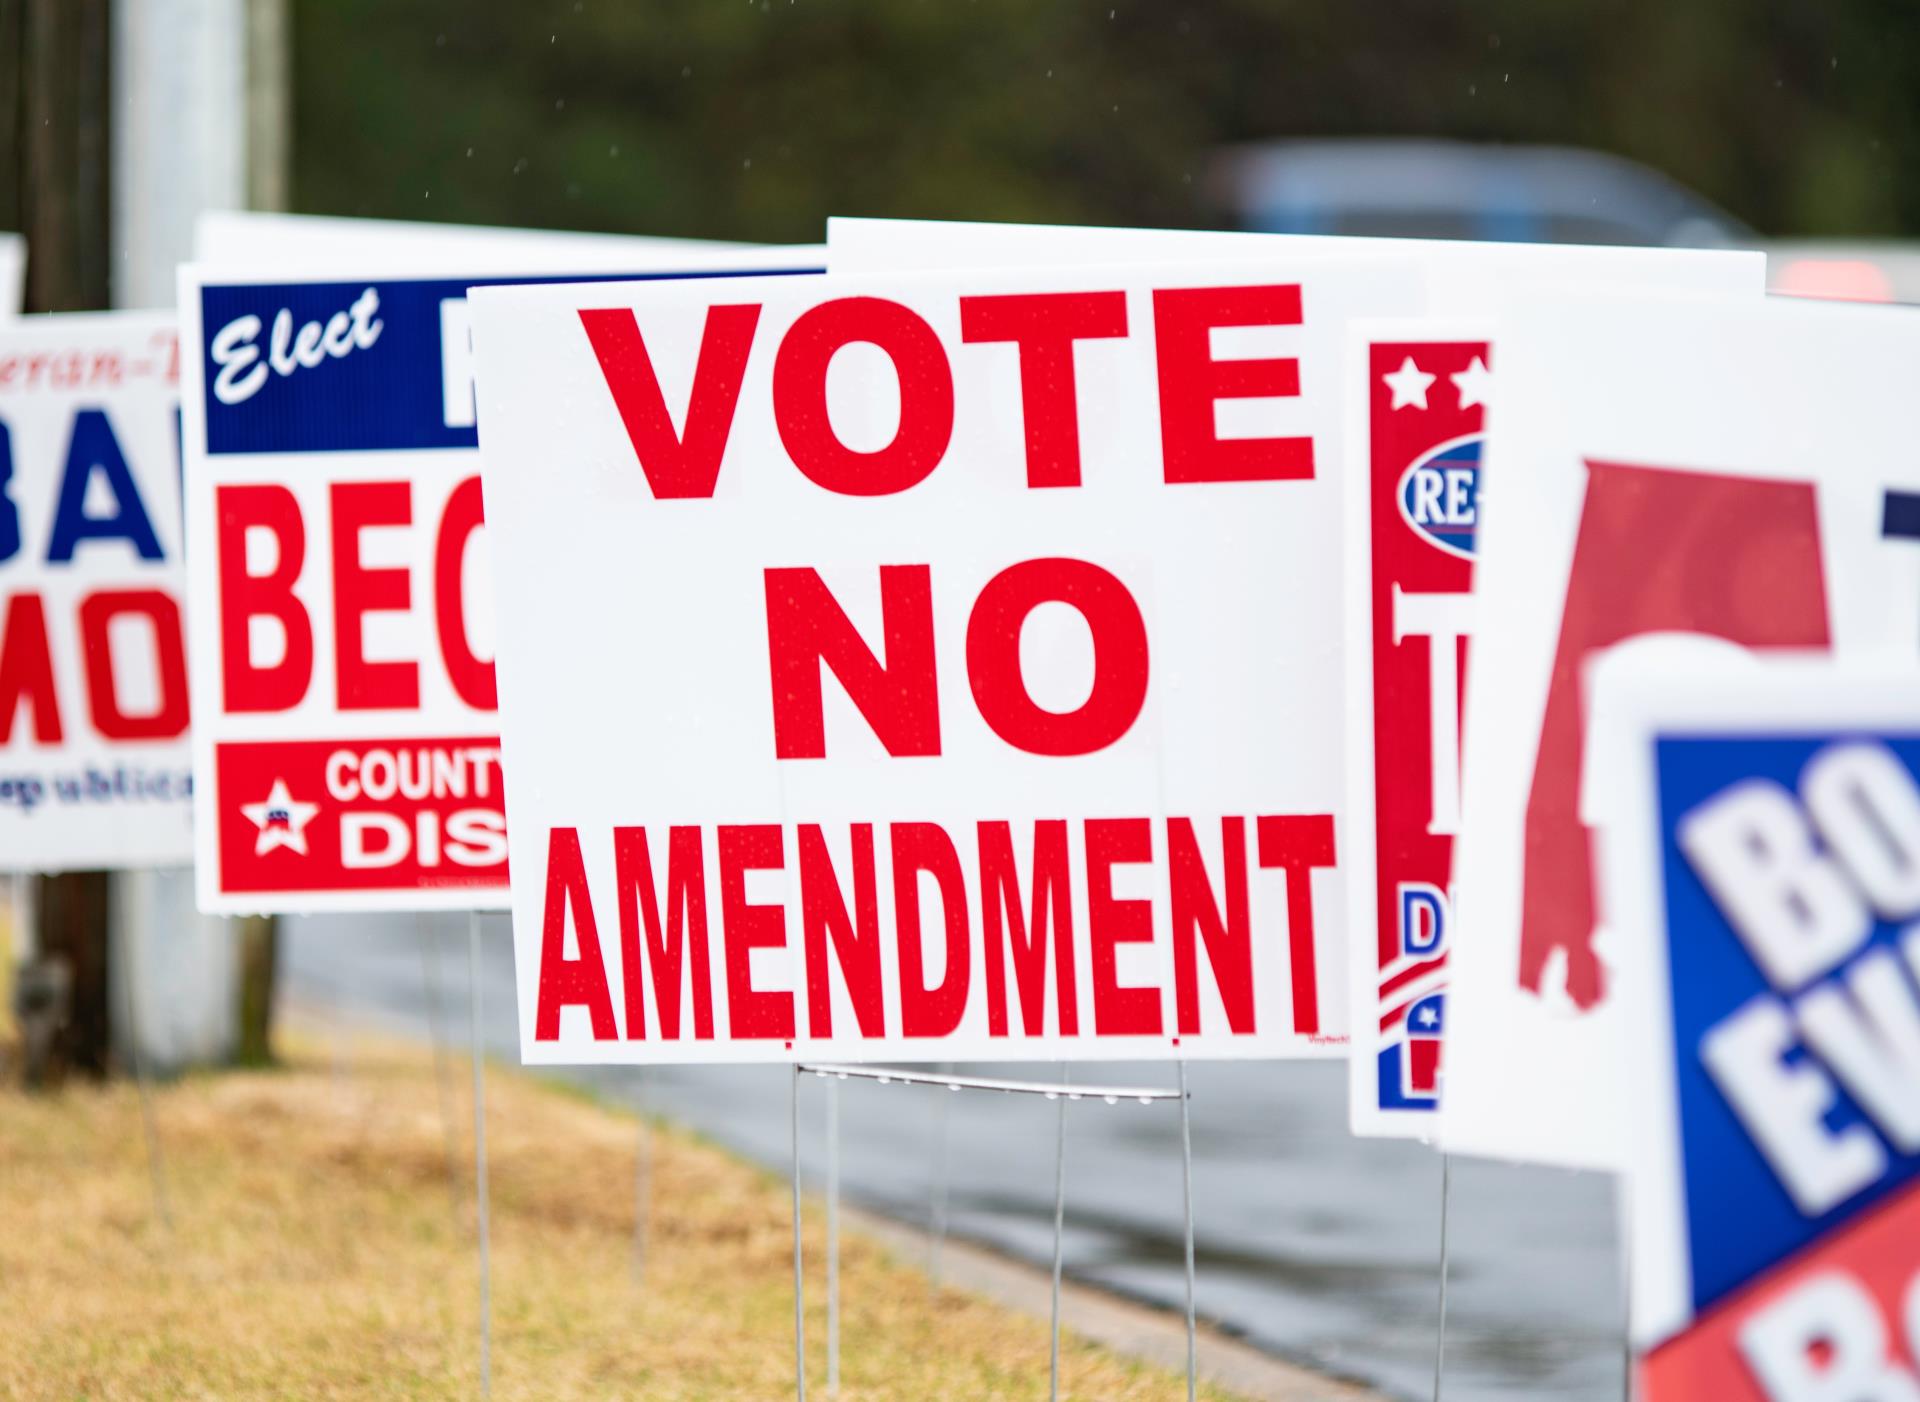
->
xmin=0 ymin=1041 xmax=1225 ymax=1402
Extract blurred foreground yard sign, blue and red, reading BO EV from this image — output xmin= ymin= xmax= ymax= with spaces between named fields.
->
xmin=1597 ymin=665 xmax=1920 ymax=1402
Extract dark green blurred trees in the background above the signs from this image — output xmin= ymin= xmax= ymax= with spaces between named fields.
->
xmin=294 ymin=0 xmax=1920 ymax=240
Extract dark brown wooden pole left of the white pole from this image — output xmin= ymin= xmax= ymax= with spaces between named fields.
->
xmin=0 ymin=0 xmax=111 ymax=1077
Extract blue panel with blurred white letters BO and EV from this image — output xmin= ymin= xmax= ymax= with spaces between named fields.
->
xmin=1655 ymin=728 xmax=1920 ymax=1314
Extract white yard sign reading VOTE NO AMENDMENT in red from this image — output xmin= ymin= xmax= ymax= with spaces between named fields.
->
xmin=474 ymin=261 xmax=1419 ymax=1062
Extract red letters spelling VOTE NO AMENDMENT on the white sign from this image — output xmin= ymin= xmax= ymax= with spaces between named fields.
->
xmin=534 ymin=284 xmax=1334 ymax=1043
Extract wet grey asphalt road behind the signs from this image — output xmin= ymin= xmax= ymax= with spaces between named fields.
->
xmin=280 ymin=916 xmax=1622 ymax=1402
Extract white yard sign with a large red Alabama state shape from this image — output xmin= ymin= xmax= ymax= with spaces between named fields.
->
xmin=1440 ymin=296 xmax=1920 ymax=1168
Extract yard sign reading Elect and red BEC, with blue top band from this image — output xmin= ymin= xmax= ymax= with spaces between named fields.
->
xmin=180 ymin=259 xmax=825 ymax=912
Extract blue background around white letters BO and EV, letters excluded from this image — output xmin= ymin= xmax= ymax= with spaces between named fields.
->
xmin=1655 ymin=734 xmax=1920 ymax=1312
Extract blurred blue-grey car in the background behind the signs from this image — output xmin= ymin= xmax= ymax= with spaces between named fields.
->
xmin=1210 ymin=136 xmax=1920 ymax=302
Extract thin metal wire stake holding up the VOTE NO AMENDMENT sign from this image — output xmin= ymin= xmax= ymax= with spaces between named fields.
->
xmin=793 ymin=1062 xmax=1198 ymax=1402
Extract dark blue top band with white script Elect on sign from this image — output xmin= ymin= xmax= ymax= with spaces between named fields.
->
xmin=200 ymin=267 xmax=824 ymax=453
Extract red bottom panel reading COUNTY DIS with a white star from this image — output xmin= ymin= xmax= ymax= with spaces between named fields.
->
xmin=213 ymin=736 xmax=507 ymax=895
